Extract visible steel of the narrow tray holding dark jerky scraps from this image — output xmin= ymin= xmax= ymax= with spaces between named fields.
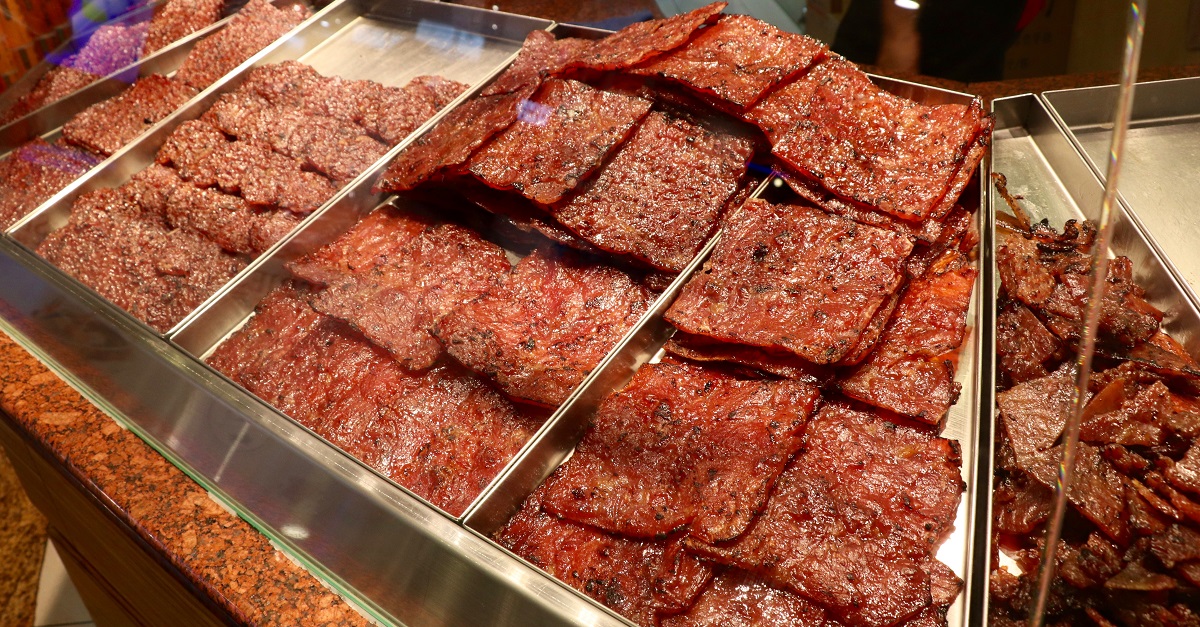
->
xmin=970 ymin=94 xmax=1200 ymax=620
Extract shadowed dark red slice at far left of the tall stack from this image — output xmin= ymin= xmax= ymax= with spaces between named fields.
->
xmin=372 ymin=85 xmax=536 ymax=193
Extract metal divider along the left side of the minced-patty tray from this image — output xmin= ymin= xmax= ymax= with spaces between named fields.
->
xmin=7 ymin=0 xmax=348 ymax=243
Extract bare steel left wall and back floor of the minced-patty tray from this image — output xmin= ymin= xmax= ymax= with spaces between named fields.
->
xmin=8 ymin=0 xmax=551 ymax=336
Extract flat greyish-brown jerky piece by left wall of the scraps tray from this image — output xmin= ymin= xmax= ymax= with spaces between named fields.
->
xmin=996 ymin=362 xmax=1075 ymax=464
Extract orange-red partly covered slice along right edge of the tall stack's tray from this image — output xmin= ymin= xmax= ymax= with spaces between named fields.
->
xmin=839 ymin=250 xmax=978 ymax=424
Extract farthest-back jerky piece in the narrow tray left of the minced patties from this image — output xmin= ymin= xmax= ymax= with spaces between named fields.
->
xmin=175 ymin=0 xmax=310 ymax=89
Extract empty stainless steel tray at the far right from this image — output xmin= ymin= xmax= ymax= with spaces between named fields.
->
xmin=1042 ymin=78 xmax=1200 ymax=305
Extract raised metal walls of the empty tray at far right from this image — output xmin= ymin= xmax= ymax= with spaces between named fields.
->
xmin=1038 ymin=78 xmax=1200 ymax=317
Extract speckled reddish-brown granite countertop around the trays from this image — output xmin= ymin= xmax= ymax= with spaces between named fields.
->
xmin=0 ymin=0 xmax=1200 ymax=625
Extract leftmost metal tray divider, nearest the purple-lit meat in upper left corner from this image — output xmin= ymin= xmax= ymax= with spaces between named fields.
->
xmin=0 ymin=0 xmax=319 ymax=156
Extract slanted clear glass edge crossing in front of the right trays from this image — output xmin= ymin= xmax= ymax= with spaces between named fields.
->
xmin=1030 ymin=0 xmax=1148 ymax=627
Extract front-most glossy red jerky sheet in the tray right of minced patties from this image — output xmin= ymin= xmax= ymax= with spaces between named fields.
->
xmin=209 ymin=286 xmax=538 ymax=515
